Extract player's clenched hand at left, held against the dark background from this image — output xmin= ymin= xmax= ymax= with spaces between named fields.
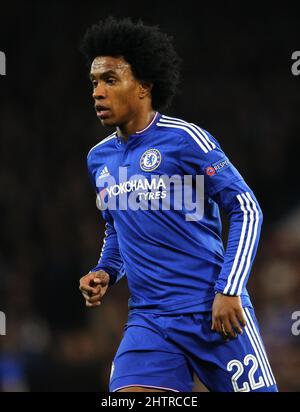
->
xmin=79 ymin=270 xmax=109 ymax=308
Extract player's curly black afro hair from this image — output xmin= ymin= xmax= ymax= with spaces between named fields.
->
xmin=80 ymin=16 xmax=181 ymax=110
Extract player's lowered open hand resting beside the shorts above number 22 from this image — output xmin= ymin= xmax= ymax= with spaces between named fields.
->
xmin=211 ymin=293 xmax=247 ymax=340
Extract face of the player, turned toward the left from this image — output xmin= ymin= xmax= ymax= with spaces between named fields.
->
xmin=90 ymin=56 xmax=140 ymax=126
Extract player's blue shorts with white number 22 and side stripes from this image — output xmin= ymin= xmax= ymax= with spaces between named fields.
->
xmin=109 ymin=307 xmax=277 ymax=392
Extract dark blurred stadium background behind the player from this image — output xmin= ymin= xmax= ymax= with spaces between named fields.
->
xmin=0 ymin=0 xmax=300 ymax=391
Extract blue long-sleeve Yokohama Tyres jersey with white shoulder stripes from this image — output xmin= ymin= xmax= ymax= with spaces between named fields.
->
xmin=87 ymin=113 xmax=262 ymax=313
